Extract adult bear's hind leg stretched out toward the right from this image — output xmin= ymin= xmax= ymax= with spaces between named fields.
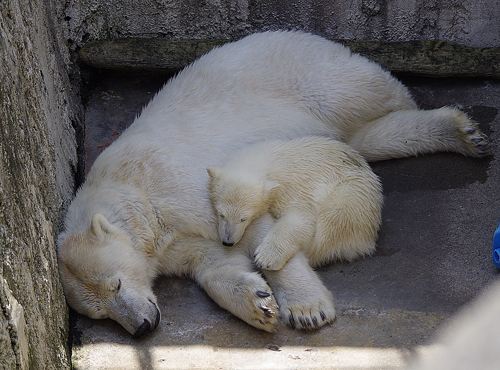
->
xmin=347 ymin=107 xmax=490 ymax=161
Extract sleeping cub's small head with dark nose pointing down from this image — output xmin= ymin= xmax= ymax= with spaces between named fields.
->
xmin=207 ymin=167 xmax=279 ymax=246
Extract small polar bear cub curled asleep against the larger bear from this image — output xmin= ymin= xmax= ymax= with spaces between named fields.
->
xmin=207 ymin=137 xmax=383 ymax=270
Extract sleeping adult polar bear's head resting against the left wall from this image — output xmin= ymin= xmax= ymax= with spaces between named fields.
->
xmin=58 ymin=214 xmax=160 ymax=336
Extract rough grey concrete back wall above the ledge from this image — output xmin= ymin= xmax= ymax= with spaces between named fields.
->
xmin=61 ymin=0 xmax=500 ymax=46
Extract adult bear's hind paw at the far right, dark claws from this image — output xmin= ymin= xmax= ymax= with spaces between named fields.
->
xmin=455 ymin=110 xmax=490 ymax=157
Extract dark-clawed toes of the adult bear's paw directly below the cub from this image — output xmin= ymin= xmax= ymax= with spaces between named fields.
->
xmin=280 ymin=293 xmax=336 ymax=330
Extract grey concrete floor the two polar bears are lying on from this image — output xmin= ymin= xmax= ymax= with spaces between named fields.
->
xmin=73 ymin=72 xmax=500 ymax=370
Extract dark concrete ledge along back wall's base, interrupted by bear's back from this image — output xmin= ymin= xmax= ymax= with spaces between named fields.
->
xmin=79 ymin=38 xmax=500 ymax=78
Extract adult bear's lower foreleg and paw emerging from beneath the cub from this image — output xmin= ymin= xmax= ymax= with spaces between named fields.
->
xmin=264 ymin=252 xmax=335 ymax=329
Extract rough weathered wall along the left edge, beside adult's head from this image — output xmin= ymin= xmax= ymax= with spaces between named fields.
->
xmin=0 ymin=0 xmax=82 ymax=369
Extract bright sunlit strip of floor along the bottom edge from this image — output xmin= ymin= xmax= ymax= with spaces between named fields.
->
xmin=76 ymin=343 xmax=438 ymax=370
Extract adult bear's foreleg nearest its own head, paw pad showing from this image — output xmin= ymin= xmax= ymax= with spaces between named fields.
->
xmin=166 ymin=238 xmax=278 ymax=332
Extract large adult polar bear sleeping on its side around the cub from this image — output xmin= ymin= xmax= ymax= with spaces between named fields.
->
xmin=58 ymin=32 xmax=488 ymax=335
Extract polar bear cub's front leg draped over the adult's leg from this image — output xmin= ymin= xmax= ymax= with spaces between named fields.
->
xmin=254 ymin=209 xmax=315 ymax=270
